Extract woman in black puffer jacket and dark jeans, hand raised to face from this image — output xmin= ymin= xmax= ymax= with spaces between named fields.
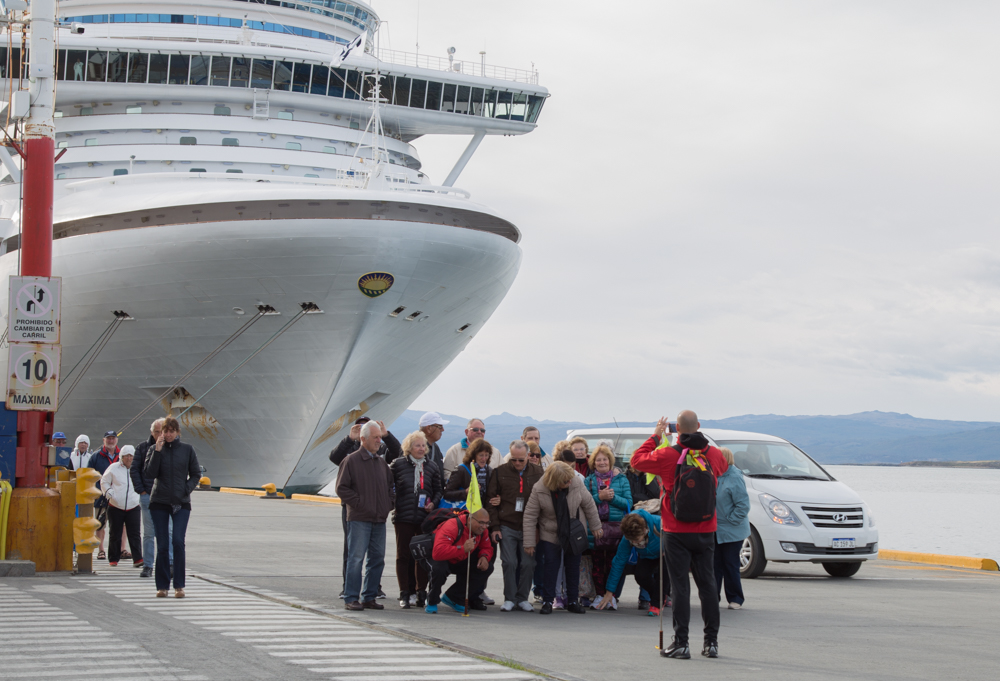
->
xmin=145 ymin=416 xmax=201 ymax=598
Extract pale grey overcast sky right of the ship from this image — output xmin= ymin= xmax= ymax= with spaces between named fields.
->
xmin=373 ymin=0 xmax=1000 ymax=422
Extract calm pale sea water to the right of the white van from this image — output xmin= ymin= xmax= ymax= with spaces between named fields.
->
xmin=824 ymin=466 xmax=1000 ymax=560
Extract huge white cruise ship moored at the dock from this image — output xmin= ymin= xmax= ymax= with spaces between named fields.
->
xmin=0 ymin=0 xmax=548 ymax=494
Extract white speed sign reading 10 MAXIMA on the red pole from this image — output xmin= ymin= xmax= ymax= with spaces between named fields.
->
xmin=7 ymin=343 xmax=61 ymax=411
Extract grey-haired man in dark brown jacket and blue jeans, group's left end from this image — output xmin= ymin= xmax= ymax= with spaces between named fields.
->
xmin=337 ymin=421 xmax=396 ymax=610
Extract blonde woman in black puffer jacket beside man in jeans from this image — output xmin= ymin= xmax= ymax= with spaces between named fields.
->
xmin=389 ymin=430 xmax=444 ymax=608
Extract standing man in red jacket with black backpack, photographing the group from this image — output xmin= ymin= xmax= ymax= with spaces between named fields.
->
xmin=630 ymin=410 xmax=729 ymax=660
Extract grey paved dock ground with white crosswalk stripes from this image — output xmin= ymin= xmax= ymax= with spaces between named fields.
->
xmin=0 ymin=492 xmax=1000 ymax=681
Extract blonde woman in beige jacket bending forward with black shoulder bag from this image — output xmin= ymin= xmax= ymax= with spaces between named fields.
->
xmin=524 ymin=461 xmax=603 ymax=615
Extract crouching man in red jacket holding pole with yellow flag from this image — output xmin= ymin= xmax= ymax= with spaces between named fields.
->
xmin=424 ymin=508 xmax=496 ymax=613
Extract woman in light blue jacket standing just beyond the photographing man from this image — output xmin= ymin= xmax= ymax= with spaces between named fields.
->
xmin=715 ymin=448 xmax=750 ymax=610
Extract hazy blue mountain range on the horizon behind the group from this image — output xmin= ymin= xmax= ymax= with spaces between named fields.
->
xmin=390 ymin=409 xmax=1000 ymax=464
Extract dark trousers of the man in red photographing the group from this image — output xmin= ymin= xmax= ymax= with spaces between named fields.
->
xmin=664 ymin=532 xmax=719 ymax=643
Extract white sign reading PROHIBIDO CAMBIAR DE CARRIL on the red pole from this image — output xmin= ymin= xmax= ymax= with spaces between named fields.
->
xmin=7 ymin=277 xmax=62 ymax=343
